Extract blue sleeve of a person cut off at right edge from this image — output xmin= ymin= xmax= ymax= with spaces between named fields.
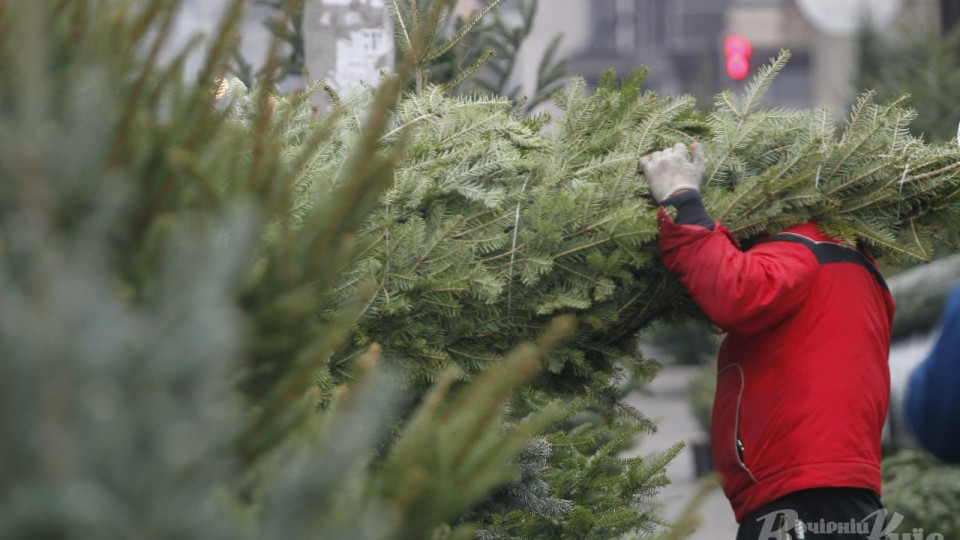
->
xmin=906 ymin=286 xmax=960 ymax=463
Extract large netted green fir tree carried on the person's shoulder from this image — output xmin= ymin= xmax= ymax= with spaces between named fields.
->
xmin=251 ymin=53 xmax=960 ymax=404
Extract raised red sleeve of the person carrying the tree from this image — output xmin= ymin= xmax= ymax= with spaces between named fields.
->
xmin=657 ymin=208 xmax=819 ymax=334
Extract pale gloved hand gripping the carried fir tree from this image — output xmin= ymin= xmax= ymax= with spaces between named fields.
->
xmin=640 ymin=143 xmax=707 ymax=203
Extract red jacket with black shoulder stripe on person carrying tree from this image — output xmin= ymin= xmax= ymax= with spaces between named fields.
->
xmin=658 ymin=208 xmax=894 ymax=522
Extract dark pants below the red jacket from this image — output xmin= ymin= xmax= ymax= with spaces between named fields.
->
xmin=737 ymin=488 xmax=884 ymax=540
